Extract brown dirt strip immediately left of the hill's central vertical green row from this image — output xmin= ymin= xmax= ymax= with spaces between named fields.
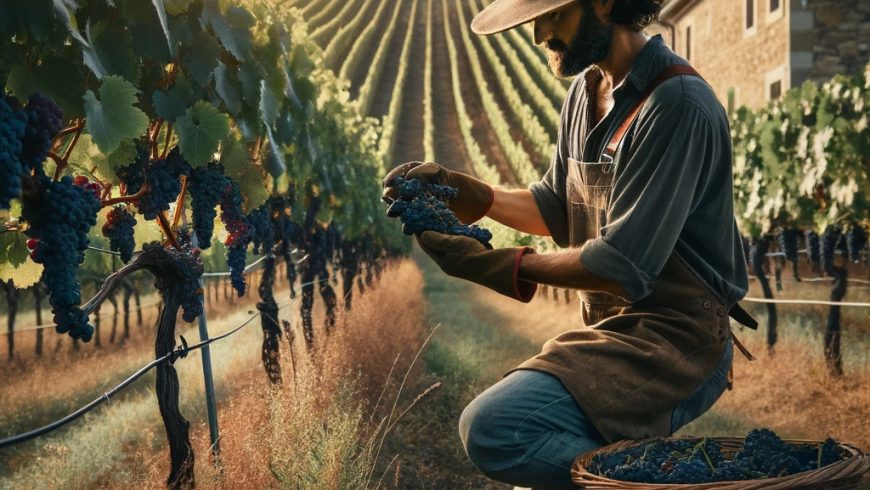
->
xmin=393 ymin=0 xmax=427 ymax=163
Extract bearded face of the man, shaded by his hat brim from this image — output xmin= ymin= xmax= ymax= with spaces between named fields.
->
xmin=534 ymin=0 xmax=612 ymax=78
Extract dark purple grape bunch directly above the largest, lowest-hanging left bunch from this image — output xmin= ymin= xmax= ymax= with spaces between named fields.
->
xmin=21 ymin=93 xmax=63 ymax=175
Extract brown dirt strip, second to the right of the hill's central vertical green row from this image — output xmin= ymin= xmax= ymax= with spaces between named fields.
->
xmin=442 ymin=3 xmax=517 ymax=186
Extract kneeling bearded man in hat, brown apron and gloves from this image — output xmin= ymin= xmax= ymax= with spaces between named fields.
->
xmin=384 ymin=0 xmax=752 ymax=488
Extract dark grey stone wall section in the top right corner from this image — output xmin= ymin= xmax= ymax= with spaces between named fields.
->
xmin=791 ymin=0 xmax=870 ymax=85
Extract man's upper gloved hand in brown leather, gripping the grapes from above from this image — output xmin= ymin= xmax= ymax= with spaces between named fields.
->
xmin=381 ymin=162 xmax=495 ymax=225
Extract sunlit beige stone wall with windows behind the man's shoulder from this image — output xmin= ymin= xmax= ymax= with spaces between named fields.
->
xmin=663 ymin=0 xmax=792 ymax=108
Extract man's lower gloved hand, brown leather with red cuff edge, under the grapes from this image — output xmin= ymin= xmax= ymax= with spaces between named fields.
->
xmin=417 ymin=231 xmax=538 ymax=303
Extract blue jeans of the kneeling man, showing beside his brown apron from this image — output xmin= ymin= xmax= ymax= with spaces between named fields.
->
xmin=459 ymin=340 xmax=733 ymax=489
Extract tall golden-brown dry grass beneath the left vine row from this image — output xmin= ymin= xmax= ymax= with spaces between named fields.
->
xmin=35 ymin=262 xmax=425 ymax=488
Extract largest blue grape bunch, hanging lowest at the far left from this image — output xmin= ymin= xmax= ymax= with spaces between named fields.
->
xmin=22 ymin=175 xmax=100 ymax=342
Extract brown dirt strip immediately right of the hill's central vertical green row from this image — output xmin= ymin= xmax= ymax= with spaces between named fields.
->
xmin=432 ymin=2 xmax=474 ymax=174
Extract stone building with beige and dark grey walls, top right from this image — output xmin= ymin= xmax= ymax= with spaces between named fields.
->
xmin=648 ymin=0 xmax=870 ymax=109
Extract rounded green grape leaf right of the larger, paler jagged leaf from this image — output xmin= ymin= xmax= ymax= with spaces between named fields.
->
xmin=175 ymin=101 xmax=230 ymax=167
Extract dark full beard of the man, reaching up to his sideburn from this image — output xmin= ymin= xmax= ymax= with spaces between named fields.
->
xmin=547 ymin=1 xmax=613 ymax=78
